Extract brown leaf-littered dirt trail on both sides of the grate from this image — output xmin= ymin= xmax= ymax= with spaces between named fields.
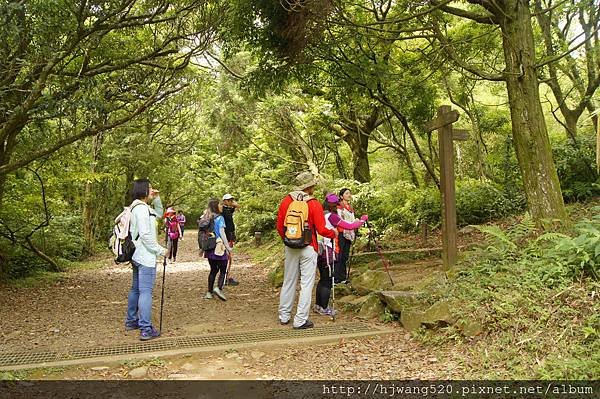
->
xmin=0 ymin=232 xmax=462 ymax=379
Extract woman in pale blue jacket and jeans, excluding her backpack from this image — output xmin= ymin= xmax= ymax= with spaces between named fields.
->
xmin=125 ymin=179 xmax=167 ymax=341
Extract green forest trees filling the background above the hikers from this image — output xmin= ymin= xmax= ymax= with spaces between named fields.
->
xmin=0 ymin=0 xmax=600 ymax=277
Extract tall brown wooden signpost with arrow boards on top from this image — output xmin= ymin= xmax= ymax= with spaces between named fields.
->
xmin=425 ymin=105 xmax=469 ymax=270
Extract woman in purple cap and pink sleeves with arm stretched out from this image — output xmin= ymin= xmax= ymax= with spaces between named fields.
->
xmin=313 ymin=194 xmax=368 ymax=316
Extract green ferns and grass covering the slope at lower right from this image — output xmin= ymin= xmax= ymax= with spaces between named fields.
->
xmin=420 ymin=212 xmax=600 ymax=379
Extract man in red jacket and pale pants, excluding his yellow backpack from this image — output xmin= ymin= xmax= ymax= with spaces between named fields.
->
xmin=277 ymin=172 xmax=338 ymax=329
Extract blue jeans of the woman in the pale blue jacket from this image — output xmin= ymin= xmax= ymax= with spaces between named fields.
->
xmin=126 ymin=261 xmax=156 ymax=331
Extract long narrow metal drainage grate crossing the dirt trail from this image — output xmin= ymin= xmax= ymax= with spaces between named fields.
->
xmin=0 ymin=324 xmax=380 ymax=367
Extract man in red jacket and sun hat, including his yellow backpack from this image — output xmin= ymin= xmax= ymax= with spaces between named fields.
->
xmin=277 ymin=172 xmax=338 ymax=329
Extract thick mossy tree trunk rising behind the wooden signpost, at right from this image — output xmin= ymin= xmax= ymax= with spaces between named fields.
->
xmin=500 ymin=0 xmax=567 ymax=225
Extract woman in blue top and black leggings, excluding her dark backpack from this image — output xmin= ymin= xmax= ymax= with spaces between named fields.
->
xmin=201 ymin=198 xmax=232 ymax=301
